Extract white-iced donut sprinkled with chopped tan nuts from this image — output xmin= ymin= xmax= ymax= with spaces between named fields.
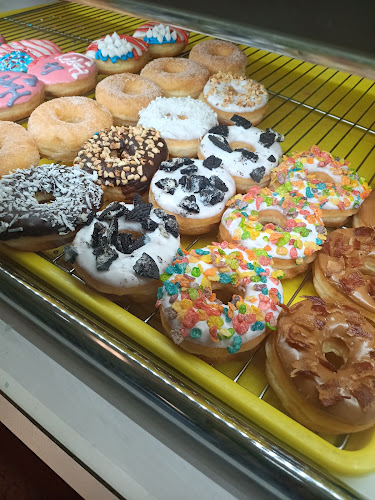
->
xmin=199 ymin=73 xmax=268 ymax=125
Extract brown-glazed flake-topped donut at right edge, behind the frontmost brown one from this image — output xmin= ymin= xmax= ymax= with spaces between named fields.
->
xmin=313 ymin=227 xmax=375 ymax=321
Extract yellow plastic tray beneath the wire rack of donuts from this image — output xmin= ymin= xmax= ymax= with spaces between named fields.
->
xmin=0 ymin=2 xmax=375 ymax=474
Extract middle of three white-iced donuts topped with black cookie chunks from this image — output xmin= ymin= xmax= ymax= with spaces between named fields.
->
xmin=149 ymin=156 xmax=235 ymax=234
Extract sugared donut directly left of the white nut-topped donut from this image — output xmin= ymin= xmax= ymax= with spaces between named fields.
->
xmin=141 ymin=57 xmax=210 ymax=97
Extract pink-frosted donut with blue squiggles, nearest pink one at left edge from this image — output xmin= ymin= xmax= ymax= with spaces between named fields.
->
xmin=0 ymin=71 xmax=44 ymax=121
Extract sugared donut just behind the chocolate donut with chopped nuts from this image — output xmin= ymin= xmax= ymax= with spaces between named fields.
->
xmin=27 ymin=96 xmax=112 ymax=164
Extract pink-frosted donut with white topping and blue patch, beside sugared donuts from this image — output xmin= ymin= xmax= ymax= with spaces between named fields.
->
xmin=27 ymin=52 xmax=98 ymax=97
